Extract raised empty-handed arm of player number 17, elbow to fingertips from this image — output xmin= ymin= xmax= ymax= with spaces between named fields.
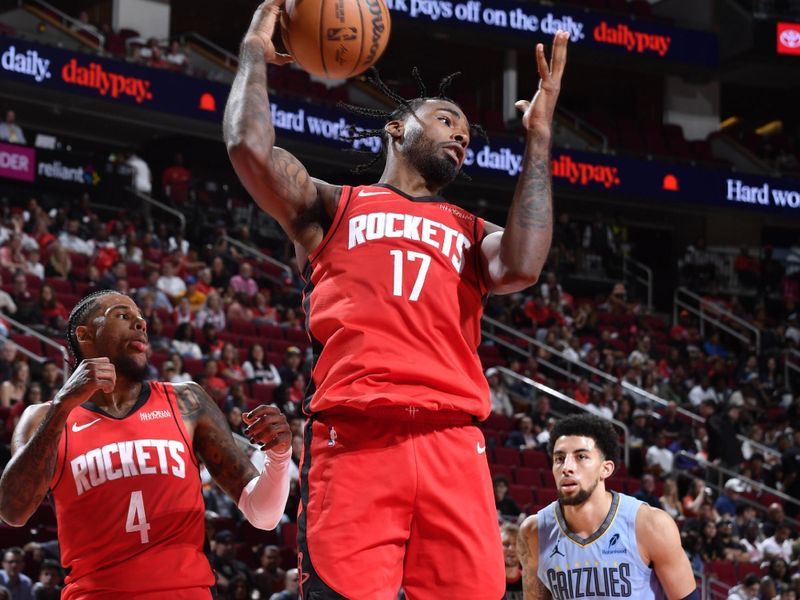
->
xmin=481 ymin=31 xmax=569 ymax=294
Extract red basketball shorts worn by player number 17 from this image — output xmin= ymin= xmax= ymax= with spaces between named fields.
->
xmin=298 ymin=407 xmax=505 ymax=600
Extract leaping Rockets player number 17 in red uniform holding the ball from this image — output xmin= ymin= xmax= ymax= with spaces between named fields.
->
xmin=224 ymin=0 xmax=568 ymax=600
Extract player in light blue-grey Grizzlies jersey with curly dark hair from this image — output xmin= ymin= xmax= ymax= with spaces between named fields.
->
xmin=517 ymin=415 xmax=699 ymax=600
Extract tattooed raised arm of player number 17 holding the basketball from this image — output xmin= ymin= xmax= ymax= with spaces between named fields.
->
xmin=223 ymin=0 xmax=341 ymax=251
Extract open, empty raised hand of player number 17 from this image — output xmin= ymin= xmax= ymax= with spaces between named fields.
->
xmin=514 ymin=31 xmax=569 ymax=139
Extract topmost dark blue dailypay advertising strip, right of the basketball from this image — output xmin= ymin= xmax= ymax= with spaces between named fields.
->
xmin=387 ymin=0 xmax=719 ymax=67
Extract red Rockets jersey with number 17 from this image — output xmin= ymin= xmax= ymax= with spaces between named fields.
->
xmin=304 ymin=184 xmax=491 ymax=419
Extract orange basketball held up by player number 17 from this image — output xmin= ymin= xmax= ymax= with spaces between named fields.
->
xmin=281 ymin=0 xmax=392 ymax=79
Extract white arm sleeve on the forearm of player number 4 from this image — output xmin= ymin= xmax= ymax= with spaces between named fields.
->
xmin=239 ymin=449 xmax=292 ymax=530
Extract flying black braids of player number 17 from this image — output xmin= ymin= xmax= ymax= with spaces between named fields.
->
xmin=337 ymin=67 xmax=489 ymax=181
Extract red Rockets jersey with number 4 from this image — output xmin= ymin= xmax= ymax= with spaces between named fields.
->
xmin=50 ymin=382 xmax=214 ymax=599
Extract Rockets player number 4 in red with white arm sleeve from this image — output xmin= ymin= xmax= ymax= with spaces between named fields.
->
xmin=0 ymin=290 xmax=291 ymax=600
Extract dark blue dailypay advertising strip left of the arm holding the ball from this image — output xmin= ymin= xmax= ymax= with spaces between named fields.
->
xmin=0 ymin=37 xmax=230 ymax=122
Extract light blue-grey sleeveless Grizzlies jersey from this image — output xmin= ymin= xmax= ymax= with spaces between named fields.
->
xmin=538 ymin=492 xmax=666 ymax=600
